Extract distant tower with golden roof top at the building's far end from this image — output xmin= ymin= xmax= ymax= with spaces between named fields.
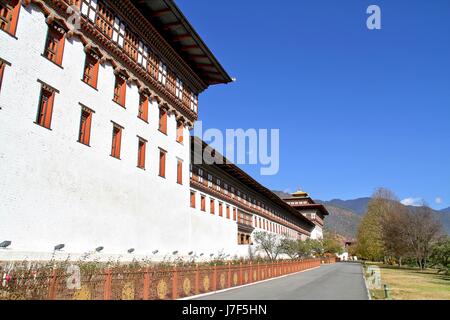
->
xmin=284 ymin=191 xmax=329 ymax=239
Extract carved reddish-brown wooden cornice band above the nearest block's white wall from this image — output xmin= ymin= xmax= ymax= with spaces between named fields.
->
xmin=23 ymin=0 xmax=198 ymax=122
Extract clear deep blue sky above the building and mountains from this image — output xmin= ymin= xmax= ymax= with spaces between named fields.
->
xmin=177 ymin=0 xmax=450 ymax=209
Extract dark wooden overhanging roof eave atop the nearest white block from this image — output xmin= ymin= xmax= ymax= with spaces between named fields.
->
xmin=131 ymin=0 xmax=232 ymax=85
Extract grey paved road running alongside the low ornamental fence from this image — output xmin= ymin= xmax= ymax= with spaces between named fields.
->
xmin=198 ymin=263 xmax=368 ymax=300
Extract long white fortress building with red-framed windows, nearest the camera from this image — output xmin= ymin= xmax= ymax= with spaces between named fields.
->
xmin=0 ymin=0 xmax=324 ymax=260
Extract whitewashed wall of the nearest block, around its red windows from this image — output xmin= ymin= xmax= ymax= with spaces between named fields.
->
xmin=0 ymin=6 xmax=196 ymax=256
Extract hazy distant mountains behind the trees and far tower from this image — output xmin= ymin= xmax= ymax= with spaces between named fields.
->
xmin=274 ymin=191 xmax=450 ymax=240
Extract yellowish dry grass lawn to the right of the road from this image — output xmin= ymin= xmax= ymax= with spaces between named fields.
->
xmin=371 ymin=264 xmax=450 ymax=300
